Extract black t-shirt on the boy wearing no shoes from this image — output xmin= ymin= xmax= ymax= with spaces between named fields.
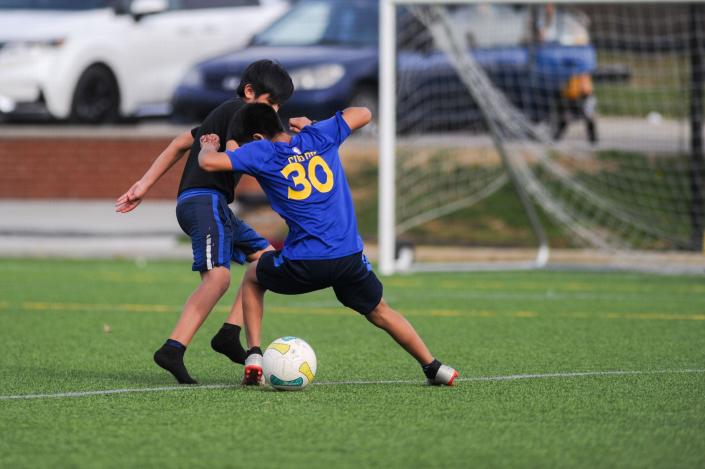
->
xmin=179 ymin=98 xmax=244 ymax=203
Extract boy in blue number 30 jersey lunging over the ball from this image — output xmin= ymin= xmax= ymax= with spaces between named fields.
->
xmin=198 ymin=104 xmax=458 ymax=386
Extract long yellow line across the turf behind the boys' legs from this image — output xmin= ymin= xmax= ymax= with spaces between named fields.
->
xmin=0 ymin=301 xmax=705 ymax=321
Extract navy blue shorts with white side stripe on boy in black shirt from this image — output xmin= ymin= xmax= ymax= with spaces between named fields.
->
xmin=176 ymin=189 xmax=269 ymax=272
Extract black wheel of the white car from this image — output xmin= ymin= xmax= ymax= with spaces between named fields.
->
xmin=71 ymin=65 xmax=120 ymax=123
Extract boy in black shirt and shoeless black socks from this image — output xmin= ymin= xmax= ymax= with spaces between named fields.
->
xmin=115 ymin=60 xmax=294 ymax=384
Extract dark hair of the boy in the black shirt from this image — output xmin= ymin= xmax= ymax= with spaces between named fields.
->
xmin=237 ymin=60 xmax=294 ymax=104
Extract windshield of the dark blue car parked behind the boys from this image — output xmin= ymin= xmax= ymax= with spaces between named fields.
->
xmin=252 ymin=0 xmax=378 ymax=46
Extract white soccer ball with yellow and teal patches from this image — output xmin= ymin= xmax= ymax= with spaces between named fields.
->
xmin=262 ymin=337 xmax=316 ymax=391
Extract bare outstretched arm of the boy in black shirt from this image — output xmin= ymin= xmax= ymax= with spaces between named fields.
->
xmin=115 ymin=131 xmax=193 ymax=213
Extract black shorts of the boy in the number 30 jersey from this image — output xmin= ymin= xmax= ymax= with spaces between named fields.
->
xmin=257 ymin=251 xmax=382 ymax=315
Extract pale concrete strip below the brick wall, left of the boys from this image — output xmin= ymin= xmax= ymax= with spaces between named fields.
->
xmin=0 ymin=199 xmax=191 ymax=259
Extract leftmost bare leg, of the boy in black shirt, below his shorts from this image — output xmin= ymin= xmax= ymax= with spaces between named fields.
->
xmin=169 ymin=267 xmax=230 ymax=345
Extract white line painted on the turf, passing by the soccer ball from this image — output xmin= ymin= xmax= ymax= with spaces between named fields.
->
xmin=0 ymin=369 xmax=705 ymax=401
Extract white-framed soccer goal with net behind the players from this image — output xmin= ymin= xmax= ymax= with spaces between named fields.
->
xmin=379 ymin=0 xmax=705 ymax=274
